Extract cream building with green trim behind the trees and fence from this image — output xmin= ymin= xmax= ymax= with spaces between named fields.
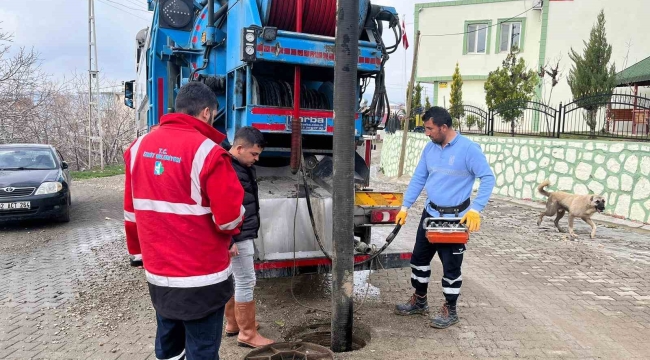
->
xmin=415 ymin=0 xmax=650 ymax=106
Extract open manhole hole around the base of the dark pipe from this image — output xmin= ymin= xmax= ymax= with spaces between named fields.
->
xmin=286 ymin=322 xmax=371 ymax=351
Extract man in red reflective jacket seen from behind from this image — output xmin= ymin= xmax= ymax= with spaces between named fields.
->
xmin=124 ymin=82 xmax=245 ymax=360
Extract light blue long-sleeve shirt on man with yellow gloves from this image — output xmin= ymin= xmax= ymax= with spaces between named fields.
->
xmin=402 ymin=134 xmax=495 ymax=217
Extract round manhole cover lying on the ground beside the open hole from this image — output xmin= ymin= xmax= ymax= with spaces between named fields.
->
xmin=244 ymin=341 xmax=334 ymax=360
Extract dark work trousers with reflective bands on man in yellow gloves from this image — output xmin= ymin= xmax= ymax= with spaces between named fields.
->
xmin=411 ymin=210 xmax=465 ymax=305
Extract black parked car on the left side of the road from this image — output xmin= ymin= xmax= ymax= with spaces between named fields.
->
xmin=0 ymin=144 xmax=72 ymax=222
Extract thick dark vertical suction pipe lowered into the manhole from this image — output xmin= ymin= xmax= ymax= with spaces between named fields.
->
xmin=331 ymin=0 xmax=359 ymax=352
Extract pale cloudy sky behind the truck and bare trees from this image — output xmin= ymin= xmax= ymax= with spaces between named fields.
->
xmin=0 ymin=0 xmax=437 ymax=102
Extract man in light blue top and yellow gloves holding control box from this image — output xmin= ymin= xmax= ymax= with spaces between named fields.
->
xmin=395 ymin=106 xmax=494 ymax=329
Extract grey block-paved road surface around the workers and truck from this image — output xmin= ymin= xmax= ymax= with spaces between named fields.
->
xmin=0 ymin=173 xmax=650 ymax=360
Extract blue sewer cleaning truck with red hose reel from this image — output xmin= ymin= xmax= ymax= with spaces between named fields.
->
xmin=124 ymin=0 xmax=411 ymax=277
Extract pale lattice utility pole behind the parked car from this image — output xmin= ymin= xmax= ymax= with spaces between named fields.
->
xmin=88 ymin=0 xmax=104 ymax=170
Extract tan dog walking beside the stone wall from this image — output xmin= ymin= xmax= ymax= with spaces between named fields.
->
xmin=537 ymin=180 xmax=605 ymax=239
